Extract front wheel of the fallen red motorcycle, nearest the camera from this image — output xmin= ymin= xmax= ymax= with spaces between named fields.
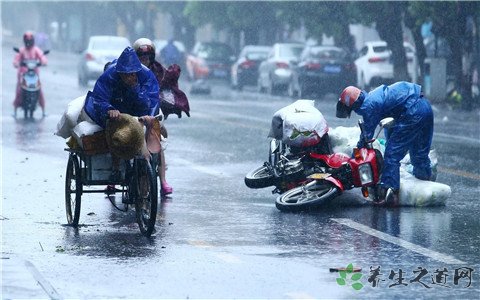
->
xmin=275 ymin=181 xmax=340 ymax=211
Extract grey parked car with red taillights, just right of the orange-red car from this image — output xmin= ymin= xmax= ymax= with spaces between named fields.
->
xmin=230 ymin=45 xmax=271 ymax=90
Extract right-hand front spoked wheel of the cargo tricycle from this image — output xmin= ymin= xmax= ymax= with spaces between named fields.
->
xmin=131 ymin=159 xmax=158 ymax=237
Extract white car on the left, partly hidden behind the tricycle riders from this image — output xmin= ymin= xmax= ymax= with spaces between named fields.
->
xmin=77 ymin=35 xmax=131 ymax=86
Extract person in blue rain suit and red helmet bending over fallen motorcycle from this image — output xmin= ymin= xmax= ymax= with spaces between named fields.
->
xmin=336 ymin=81 xmax=433 ymax=204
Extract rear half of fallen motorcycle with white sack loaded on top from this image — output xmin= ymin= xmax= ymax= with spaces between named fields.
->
xmin=245 ymin=100 xmax=333 ymax=194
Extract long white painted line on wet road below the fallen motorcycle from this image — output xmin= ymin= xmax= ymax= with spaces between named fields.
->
xmin=331 ymin=218 xmax=466 ymax=265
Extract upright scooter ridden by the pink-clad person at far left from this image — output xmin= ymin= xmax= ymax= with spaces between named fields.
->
xmin=13 ymin=47 xmax=50 ymax=119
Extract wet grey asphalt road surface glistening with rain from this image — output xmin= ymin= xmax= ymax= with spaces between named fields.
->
xmin=0 ymin=43 xmax=480 ymax=299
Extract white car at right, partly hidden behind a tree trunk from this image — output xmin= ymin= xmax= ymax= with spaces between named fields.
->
xmin=355 ymin=41 xmax=419 ymax=89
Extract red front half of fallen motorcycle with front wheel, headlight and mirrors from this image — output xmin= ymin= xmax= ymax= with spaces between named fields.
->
xmin=275 ymin=118 xmax=394 ymax=211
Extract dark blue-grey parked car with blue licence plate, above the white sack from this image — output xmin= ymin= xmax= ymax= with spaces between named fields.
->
xmin=288 ymin=46 xmax=357 ymax=98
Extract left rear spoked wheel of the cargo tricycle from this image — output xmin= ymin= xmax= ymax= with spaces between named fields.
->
xmin=65 ymin=154 xmax=82 ymax=227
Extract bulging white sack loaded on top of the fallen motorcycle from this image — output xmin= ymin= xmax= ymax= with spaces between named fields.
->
xmin=268 ymin=100 xmax=328 ymax=147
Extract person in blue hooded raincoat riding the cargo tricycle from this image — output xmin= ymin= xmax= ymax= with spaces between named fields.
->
xmin=84 ymin=47 xmax=160 ymax=128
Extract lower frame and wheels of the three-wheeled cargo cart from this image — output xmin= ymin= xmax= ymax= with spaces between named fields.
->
xmin=65 ymin=149 xmax=158 ymax=237
